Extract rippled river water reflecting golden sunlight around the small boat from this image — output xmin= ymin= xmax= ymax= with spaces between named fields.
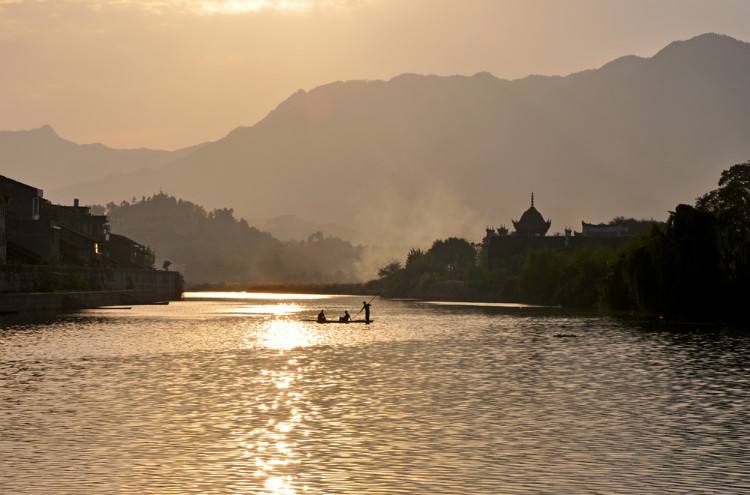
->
xmin=0 ymin=293 xmax=750 ymax=495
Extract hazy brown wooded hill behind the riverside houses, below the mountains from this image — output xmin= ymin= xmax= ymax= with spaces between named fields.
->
xmin=100 ymin=193 xmax=361 ymax=283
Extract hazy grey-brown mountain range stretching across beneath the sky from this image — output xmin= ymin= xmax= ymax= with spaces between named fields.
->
xmin=0 ymin=34 xmax=750 ymax=245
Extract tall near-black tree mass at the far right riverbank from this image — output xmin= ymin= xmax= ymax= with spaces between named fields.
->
xmin=618 ymin=162 xmax=750 ymax=319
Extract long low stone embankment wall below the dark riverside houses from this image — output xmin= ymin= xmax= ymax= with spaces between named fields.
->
xmin=0 ymin=265 xmax=183 ymax=312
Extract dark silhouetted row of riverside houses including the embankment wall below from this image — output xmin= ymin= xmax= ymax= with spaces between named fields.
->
xmin=0 ymin=175 xmax=183 ymax=306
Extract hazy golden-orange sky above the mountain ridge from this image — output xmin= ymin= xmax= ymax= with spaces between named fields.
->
xmin=0 ymin=0 xmax=750 ymax=148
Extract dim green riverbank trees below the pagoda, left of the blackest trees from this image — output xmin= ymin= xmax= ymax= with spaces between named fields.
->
xmin=374 ymin=238 xmax=614 ymax=307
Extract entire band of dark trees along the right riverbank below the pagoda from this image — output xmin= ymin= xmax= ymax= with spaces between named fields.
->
xmin=378 ymin=162 xmax=750 ymax=320
